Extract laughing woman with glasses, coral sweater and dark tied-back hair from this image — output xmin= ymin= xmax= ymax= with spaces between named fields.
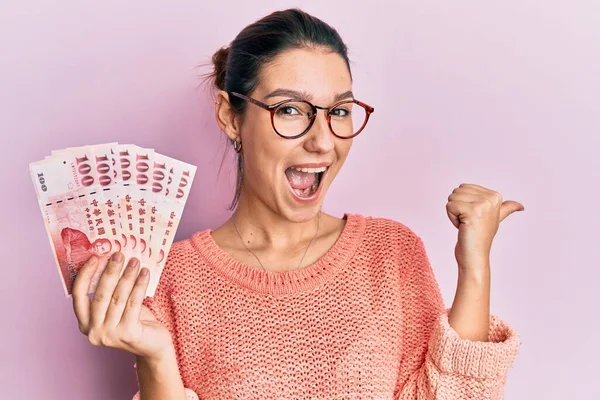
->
xmin=73 ymin=10 xmax=523 ymax=400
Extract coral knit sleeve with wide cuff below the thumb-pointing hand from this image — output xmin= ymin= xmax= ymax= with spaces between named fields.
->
xmin=395 ymin=235 xmax=519 ymax=400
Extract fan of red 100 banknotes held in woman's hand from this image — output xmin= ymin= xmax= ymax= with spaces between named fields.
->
xmin=29 ymin=143 xmax=196 ymax=297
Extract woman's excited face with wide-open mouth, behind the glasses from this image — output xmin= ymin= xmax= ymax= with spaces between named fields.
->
xmin=240 ymin=49 xmax=353 ymax=222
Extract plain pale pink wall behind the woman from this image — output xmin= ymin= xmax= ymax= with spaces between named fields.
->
xmin=0 ymin=0 xmax=600 ymax=400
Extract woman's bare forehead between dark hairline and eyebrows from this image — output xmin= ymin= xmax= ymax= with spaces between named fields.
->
xmin=255 ymin=48 xmax=352 ymax=101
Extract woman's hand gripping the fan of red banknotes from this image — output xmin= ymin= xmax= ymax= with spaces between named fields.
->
xmin=72 ymin=253 xmax=173 ymax=360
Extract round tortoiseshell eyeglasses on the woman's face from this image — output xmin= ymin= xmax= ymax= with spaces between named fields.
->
xmin=229 ymin=92 xmax=375 ymax=139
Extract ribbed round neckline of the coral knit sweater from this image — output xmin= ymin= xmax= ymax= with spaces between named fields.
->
xmin=190 ymin=213 xmax=366 ymax=295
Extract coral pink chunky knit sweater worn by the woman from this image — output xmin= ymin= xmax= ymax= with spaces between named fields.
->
xmin=135 ymin=214 xmax=519 ymax=400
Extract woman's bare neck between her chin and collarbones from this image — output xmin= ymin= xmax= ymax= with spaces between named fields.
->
xmin=232 ymin=192 xmax=320 ymax=251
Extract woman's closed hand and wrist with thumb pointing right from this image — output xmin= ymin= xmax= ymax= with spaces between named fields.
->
xmin=446 ymin=183 xmax=525 ymax=272
